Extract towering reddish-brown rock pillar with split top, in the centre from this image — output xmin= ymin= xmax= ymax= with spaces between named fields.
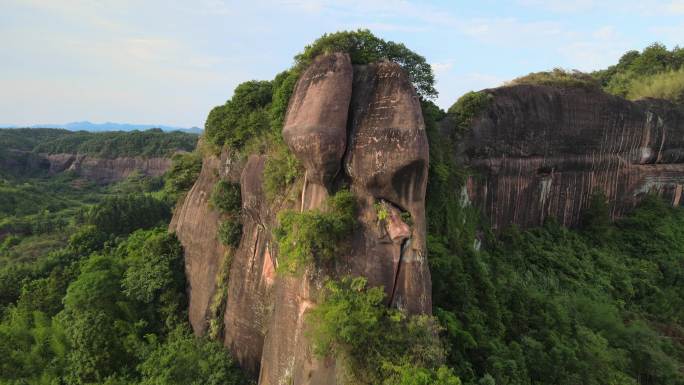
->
xmin=171 ymin=54 xmax=431 ymax=385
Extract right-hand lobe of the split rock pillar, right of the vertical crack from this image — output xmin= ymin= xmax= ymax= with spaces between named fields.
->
xmin=345 ymin=62 xmax=432 ymax=313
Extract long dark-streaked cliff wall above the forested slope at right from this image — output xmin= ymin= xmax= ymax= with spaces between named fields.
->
xmin=459 ymin=85 xmax=684 ymax=228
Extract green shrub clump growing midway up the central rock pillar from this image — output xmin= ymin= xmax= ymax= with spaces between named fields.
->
xmin=274 ymin=190 xmax=356 ymax=274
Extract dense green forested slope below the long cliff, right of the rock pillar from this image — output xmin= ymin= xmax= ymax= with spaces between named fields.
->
xmin=423 ymin=103 xmax=684 ymax=384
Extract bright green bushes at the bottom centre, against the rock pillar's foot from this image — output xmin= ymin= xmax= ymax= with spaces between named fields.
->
xmin=307 ymin=277 xmax=460 ymax=385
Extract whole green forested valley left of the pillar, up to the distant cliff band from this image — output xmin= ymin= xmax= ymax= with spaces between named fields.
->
xmin=0 ymin=130 xmax=248 ymax=384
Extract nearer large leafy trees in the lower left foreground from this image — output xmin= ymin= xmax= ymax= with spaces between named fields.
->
xmin=0 ymin=201 xmax=251 ymax=384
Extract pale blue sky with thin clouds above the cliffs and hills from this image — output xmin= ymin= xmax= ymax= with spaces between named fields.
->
xmin=0 ymin=0 xmax=684 ymax=127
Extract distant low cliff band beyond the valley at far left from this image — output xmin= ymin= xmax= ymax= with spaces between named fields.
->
xmin=44 ymin=154 xmax=171 ymax=184
